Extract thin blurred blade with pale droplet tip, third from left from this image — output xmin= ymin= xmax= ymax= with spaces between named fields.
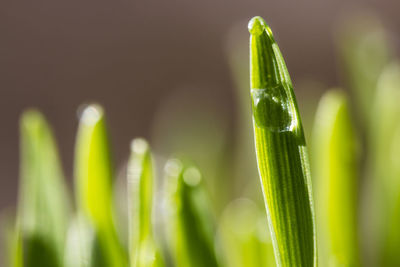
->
xmin=128 ymin=138 xmax=164 ymax=267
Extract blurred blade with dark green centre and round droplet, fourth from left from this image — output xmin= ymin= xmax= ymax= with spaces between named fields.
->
xmin=165 ymin=160 xmax=219 ymax=267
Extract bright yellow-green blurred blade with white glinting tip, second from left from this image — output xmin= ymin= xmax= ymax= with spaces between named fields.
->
xmin=74 ymin=105 xmax=128 ymax=267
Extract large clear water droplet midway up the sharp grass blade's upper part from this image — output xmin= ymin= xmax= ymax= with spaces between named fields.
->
xmin=251 ymin=85 xmax=294 ymax=132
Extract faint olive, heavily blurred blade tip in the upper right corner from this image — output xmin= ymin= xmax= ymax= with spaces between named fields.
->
xmin=336 ymin=13 xmax=393 ymax=123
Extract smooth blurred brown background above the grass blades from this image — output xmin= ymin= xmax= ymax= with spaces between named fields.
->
xmin=0 ymin=0 xmax=400 ymax=214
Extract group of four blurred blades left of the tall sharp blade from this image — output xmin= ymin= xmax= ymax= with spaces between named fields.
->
xmin=10 ymin=105 xmax=228 ymax=267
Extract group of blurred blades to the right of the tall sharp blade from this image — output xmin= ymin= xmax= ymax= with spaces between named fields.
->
xmin=311 ymin=14 xmax=400 ymax=267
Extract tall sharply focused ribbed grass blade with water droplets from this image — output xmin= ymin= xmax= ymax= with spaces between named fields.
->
xmin=249 ymin=17 xmax=317 ymax=267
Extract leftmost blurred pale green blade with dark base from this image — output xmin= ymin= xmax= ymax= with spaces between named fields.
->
xmin=17 ymin=110 xmax=69 ymax=267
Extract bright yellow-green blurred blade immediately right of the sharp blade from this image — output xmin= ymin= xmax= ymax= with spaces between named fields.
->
xmin=312 ymin=90 xmax=360 ymax=267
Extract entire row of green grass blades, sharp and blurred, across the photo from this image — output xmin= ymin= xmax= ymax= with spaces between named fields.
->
xmin=4 ymin=13 xmax=400 ymax=267
